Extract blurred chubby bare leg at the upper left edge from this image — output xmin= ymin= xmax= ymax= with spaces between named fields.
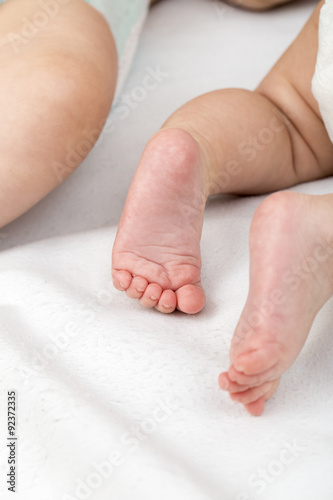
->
xmin=0 ymin=0 xmax=117 ymax=227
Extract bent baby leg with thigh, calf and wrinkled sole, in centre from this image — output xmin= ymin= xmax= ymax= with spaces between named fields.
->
xmin=112 ymin=0 xmax=333 ymax=313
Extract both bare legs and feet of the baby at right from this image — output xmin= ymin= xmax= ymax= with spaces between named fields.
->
xmin=112 ymin=3 xmax=333 ymax=415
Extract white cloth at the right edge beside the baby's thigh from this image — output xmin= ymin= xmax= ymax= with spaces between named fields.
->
xmin=312 ymin=0 xmax=333 ymax=142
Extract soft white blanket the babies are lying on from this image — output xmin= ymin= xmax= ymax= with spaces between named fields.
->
xmin=0 ymin=0 xmax=333 ymax=500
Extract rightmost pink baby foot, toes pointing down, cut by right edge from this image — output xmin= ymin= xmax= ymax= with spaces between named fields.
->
xmin=219 ymin=192 xmax=333 ymax=415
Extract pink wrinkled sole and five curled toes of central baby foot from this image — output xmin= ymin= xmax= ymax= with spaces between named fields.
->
xmin=112 ymin=129 xmax=206 ymax=314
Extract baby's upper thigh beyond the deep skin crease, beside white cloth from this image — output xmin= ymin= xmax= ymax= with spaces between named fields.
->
xmin=256 ymin=1 xmax=333 ymax=182
